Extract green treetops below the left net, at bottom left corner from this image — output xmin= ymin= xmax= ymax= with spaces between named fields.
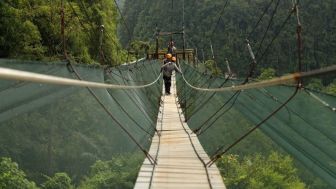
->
xmin=0 ymin=153 xmax=143 ymax=189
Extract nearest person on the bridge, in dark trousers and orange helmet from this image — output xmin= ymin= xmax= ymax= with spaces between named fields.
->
xmin=161 ymin=57 xmax=182 ymax=95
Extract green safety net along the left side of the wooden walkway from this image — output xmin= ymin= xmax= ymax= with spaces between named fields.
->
xmin=0 ymin=59 xmax=162 ymax=185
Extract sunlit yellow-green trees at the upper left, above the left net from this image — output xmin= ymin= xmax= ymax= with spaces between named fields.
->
xmin=0 ymin=0 xmax=126 ymax=64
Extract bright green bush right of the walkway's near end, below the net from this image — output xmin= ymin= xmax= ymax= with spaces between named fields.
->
xmin=217 ymin=152 xmax=305 ymax=189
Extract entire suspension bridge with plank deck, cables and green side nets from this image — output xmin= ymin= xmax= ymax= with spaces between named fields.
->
xmin=0 ymin=1 xmax=336 ymax=189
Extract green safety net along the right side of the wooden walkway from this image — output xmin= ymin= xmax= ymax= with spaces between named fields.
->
xmin=177 ymin=63 xmax=336 ymax=186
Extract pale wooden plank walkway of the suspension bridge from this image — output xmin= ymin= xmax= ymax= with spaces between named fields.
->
xmin=134 ymin=77 xmax=225 ymax=189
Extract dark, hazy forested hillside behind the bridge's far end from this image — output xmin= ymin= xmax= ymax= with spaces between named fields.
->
xmin=121 ymin=0 xmax=336 ymax=81
